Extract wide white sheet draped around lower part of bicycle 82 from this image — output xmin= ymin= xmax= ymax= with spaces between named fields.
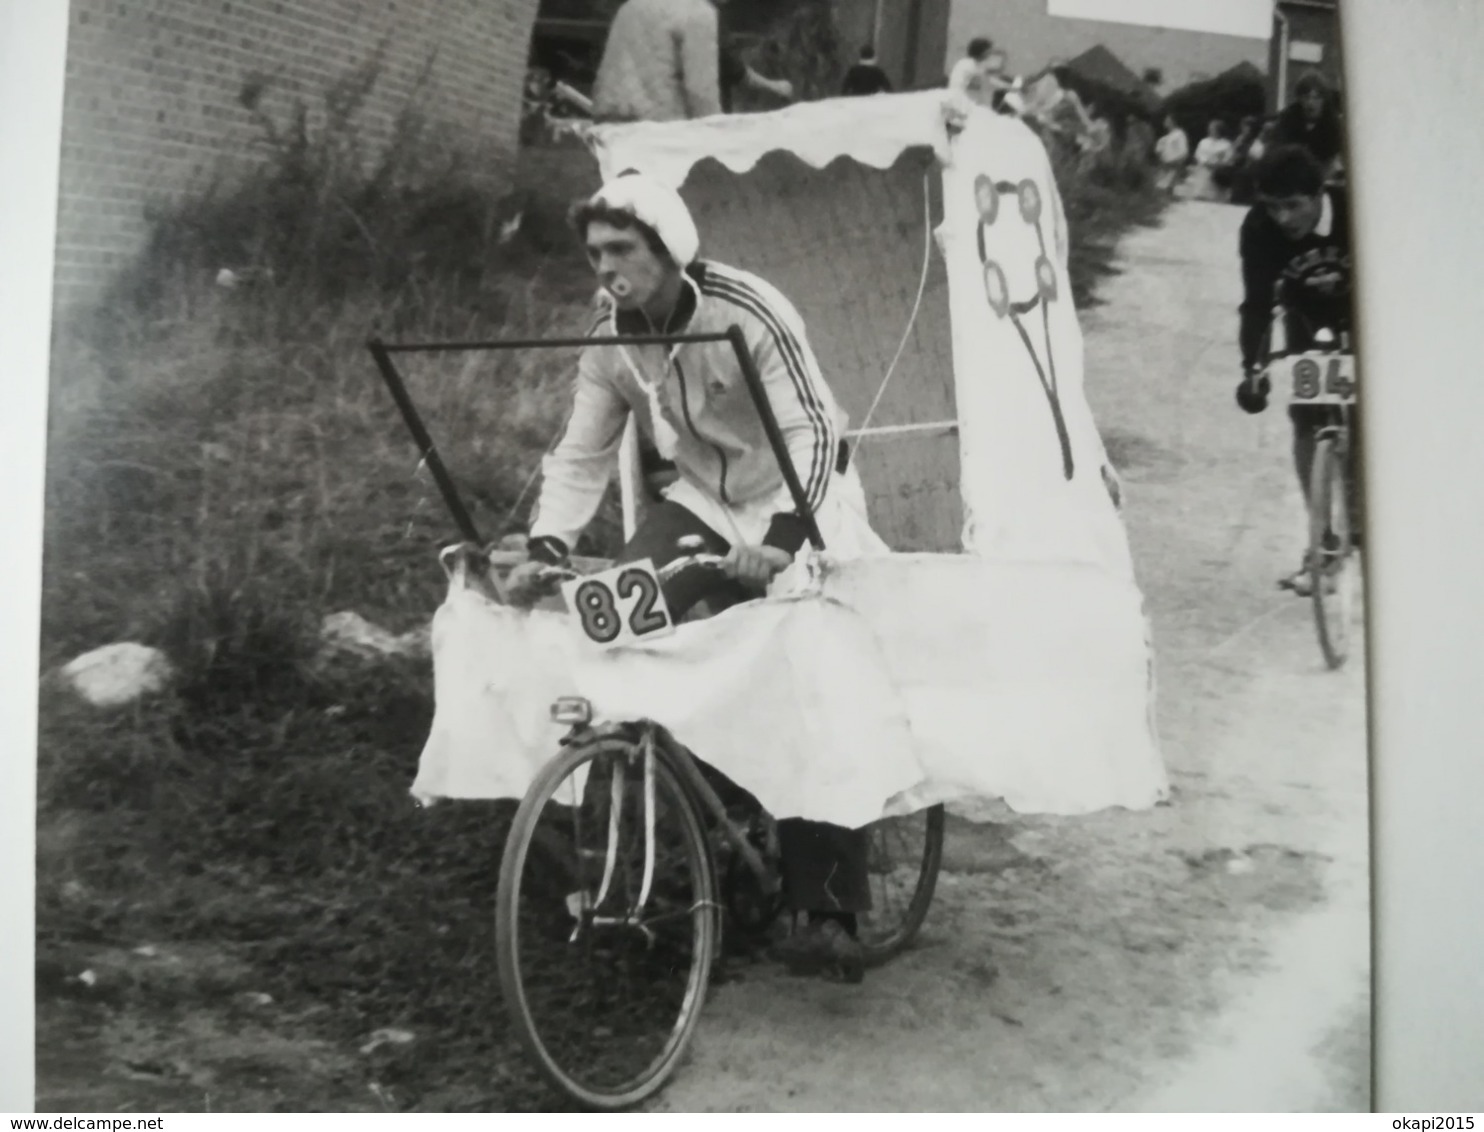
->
xmin=413 ymin=555 xmax=1166 ymax=826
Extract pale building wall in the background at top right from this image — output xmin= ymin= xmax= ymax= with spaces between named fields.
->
xmin=947 ymin=0 xmax=1267 ymax=92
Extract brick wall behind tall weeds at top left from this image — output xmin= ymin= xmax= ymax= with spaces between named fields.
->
xmin=56 ymin=0 xmax=537 ymax=313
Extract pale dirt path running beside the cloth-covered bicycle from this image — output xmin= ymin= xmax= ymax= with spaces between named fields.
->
xmin=656 ymin=203 xmax=1370 ymax=1111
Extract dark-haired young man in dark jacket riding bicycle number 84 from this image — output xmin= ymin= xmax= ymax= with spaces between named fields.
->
xmin=1236 ymin=145 xmax=1358 ymax=596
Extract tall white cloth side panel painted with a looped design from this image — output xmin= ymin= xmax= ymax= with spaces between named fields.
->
xmin=938 ymin=111 xmax=1132 ymax=577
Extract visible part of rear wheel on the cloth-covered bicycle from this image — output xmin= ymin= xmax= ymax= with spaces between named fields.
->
xmin=858 ymin=806 xmax=944 ymax=966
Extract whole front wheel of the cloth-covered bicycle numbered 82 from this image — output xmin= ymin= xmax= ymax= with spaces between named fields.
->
xmin=496 ymin=736 xmax=720 ymax=1108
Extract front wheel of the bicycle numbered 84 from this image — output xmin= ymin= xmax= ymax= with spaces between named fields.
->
xmin=1309 ymin=436 xmax=1356 ymax=669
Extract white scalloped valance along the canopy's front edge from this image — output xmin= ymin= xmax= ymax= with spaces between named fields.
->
xmin=585 ymin=91 xmax=948 ymax=188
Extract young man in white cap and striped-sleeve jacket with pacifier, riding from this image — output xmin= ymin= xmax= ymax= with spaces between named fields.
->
xmin=508 ymin=174 xmax=886 ymax=976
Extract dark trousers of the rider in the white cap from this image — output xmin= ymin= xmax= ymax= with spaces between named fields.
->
xmin=619 ymin=500 xmax=871 ymax=912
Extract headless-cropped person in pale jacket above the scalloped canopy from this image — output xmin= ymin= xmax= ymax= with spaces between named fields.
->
xmin=592 ymin=0 xmax=721 ymax=122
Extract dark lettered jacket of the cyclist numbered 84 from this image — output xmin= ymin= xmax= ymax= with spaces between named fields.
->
xmin=1239 ymin=188 xmax=1352 ymax=366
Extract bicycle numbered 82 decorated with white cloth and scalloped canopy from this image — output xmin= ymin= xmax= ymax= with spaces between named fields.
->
xmin=372 ymin=92 xmax=1168 ymax=1107
